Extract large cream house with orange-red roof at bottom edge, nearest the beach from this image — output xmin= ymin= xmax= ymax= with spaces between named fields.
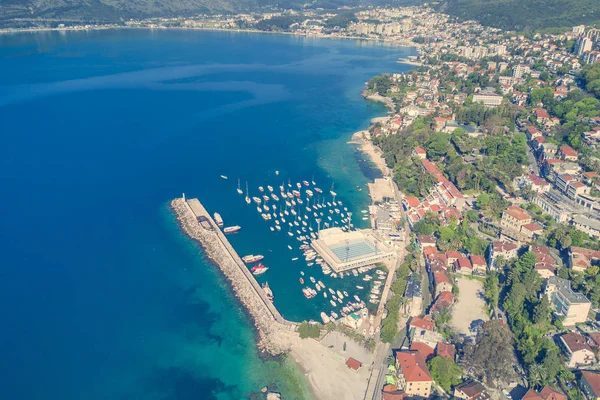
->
xmin=396 ymin=351 xmax=433 ymax=397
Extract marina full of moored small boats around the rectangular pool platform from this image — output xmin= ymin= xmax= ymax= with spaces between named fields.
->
xmin=204 ymin=176 xmax=391 ymax=322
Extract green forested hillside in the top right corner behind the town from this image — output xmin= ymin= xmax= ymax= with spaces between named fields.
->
xmin=435 ymin=0 xmax=600 ymax=31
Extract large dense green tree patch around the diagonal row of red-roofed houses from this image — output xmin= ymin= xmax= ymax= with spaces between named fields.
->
xmin=373 ymin=111 xmax=527 ymax=206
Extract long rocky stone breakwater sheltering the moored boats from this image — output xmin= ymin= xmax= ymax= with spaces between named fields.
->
xmin=171 ymin=198 xmax=297 ymax=355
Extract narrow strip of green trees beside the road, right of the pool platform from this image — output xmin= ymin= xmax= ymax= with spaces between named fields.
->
xmin=381 ymin=254 xmax=415 ymax=343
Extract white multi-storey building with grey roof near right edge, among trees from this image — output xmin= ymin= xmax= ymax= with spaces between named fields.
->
xmin=545 ymin=276 xmax=592 ymax=326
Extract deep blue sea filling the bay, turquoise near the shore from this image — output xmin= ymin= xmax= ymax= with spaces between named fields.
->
xmin=0 ymin=29 xmax=416 ymax=400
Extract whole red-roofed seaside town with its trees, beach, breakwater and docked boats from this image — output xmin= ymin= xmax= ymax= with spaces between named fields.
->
xmin=25 ymin=7 xmax=600 ymax=400
